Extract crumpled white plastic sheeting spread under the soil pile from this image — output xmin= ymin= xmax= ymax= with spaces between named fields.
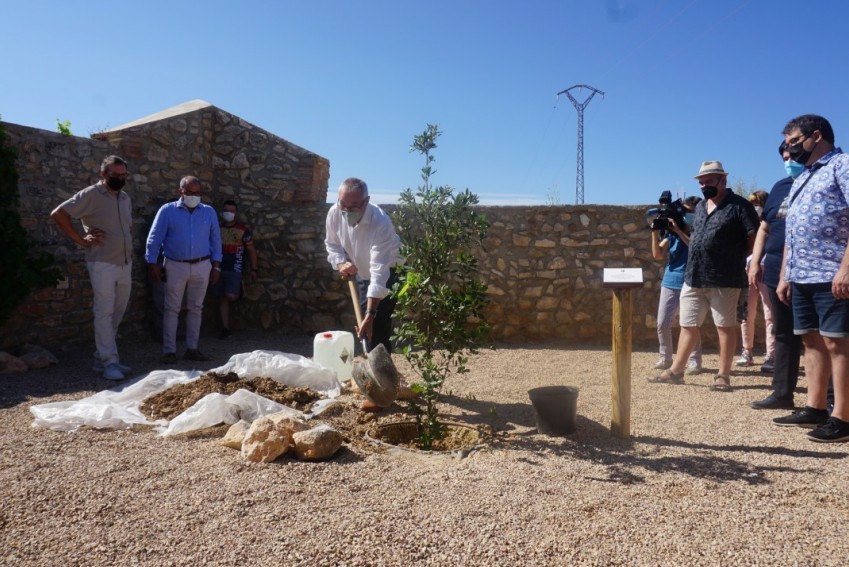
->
xmin=30 ymin=350 xmax=341 ymax=435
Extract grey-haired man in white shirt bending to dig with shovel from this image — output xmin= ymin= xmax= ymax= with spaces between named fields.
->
xmin=324 ymin=177 xmax=403 ymax=410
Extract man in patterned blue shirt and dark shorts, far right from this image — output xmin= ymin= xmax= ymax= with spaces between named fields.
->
xmin=773 ymin=114 xmax=849 ymax=443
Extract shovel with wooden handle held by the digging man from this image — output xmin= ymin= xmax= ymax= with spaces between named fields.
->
xmin=348 ymin=278 xmax=401 ymax=408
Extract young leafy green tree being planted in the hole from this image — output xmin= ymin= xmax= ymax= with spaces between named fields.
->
xmin=393 ymin=124 xmax=490 ymax=449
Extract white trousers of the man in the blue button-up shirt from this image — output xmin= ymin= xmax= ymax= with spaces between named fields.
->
xmin=162 ymin=259 xmax=212 ymax=354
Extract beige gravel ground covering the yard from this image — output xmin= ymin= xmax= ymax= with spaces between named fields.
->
xmin=0 ymin=333 xmax=849 ymax=566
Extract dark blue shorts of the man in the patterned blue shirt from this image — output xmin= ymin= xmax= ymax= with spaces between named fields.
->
xmin=791 ymin=282 xmax=849 ymax=338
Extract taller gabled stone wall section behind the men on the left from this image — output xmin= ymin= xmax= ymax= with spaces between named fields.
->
xmin=0 ymin=104 xmax=344 ymax=348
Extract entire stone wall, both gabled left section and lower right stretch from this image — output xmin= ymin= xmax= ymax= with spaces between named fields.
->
xmin=0 ymin=106 xmax=763 ymax=349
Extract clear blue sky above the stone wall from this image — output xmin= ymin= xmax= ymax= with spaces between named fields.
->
xmin=0 ymin=0 xmax=849 ymax=205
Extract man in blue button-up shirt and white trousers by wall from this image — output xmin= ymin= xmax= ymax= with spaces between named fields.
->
xmin=144 ymin=176 xmax=221 ymax=364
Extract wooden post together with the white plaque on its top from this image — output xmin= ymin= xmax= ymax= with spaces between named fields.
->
xmin=604 ymin=268 xmax=643 ymax=439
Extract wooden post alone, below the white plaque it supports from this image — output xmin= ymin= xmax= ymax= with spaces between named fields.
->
xmin=610 ymin=288 xmax=632 ymax=439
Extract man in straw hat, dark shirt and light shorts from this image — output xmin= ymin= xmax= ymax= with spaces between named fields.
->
xmin=649 ymin=161 xmax=758 ymax=392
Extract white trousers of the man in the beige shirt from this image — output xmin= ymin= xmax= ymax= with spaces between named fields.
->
xmin=86 ymin=262 xmax=133 ymax=365
